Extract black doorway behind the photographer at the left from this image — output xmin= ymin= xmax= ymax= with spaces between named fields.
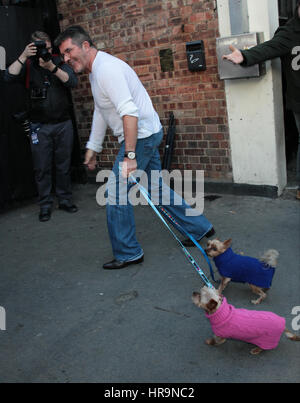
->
xmin=0 ymin=0 xmax=86 ymax=211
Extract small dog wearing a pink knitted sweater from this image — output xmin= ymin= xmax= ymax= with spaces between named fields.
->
xmin=192 ymin=287 xmax=300 ymax=354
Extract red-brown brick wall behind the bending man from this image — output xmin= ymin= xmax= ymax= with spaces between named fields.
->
xmin=57 ymin=0 xmax=231 ymax=178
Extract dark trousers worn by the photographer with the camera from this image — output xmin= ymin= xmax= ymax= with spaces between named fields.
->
xmin=31 ymin=120 xmax=73 ymax=207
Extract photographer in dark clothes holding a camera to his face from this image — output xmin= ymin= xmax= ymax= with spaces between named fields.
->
xmin=4 ymin=31 xmax=77 ymax=221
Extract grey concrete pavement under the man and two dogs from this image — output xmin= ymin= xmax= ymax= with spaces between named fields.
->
xmin=0 ymin=184 xmax=300 ymax=383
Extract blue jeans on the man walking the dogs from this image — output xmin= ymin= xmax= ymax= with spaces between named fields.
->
xmin=106 ymin=130 xmax=212 ymax=261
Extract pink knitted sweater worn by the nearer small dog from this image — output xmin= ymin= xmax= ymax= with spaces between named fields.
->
xmin=206 ymin=297 xmax=285 ymax=350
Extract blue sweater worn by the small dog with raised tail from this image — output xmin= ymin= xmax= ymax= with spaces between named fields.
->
xmin=214 ymin=248 xmax=275 ymax=288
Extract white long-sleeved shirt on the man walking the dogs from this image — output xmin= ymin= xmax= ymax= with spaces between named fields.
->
xmin=86 ymin=51 xmax=162 ymax=152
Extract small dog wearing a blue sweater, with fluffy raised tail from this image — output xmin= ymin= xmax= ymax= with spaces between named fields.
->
xmin=205 ymin=239 xmax=279 ymax=305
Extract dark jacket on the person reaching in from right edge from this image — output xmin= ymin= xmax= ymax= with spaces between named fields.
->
xmin=241 ymin=15 xmax=300 ymax=113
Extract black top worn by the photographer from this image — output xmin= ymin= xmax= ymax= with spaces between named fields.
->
xmin=4 ymin=56 xmax=78 ymax=123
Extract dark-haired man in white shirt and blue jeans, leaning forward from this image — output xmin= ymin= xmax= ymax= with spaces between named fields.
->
xmin=55 ymin=26 xmax=214 ymax=270
